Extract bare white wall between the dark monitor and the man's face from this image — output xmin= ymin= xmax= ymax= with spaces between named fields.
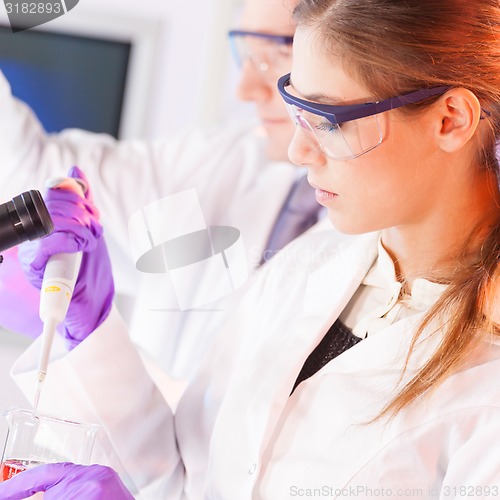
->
xmin=71 ymin=0 xmax=247 ymax=137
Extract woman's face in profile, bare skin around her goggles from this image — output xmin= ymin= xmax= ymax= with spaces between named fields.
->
xmin=289 ymin=28 xmax=447 ymax=234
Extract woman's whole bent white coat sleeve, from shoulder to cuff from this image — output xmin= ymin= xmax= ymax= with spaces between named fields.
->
xmin=7 ymin=256 xmax=286 ymax=500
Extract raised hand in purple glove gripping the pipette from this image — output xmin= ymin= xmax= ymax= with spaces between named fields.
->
xmin=19 ymin=167 xmax=114 ymax=349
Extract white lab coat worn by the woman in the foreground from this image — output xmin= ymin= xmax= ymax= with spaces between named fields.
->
xmin=11 ymin=232 xmax=500 ymax=500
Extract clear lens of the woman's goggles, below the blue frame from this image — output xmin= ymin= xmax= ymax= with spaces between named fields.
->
xmin=285 ymin=103 xmax=382 ymax=160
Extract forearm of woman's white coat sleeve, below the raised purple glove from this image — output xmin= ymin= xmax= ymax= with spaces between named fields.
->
xmin=12 ymin=310 xmax=184 ymax=500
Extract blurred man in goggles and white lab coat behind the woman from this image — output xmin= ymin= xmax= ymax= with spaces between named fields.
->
xmin=0 ymin=0 xmax=332 ymax=380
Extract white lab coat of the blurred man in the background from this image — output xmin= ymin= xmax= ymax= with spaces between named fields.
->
xmin=0 ymin=74 xmax=308 ymax=379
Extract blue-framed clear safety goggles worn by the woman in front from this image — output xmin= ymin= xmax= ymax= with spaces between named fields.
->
xmin=278 ymin=73 xmax=450 ymax=160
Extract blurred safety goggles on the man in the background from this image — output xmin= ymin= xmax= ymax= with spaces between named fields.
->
xmin=228 ymin=30 xmax=293 ymax=77
